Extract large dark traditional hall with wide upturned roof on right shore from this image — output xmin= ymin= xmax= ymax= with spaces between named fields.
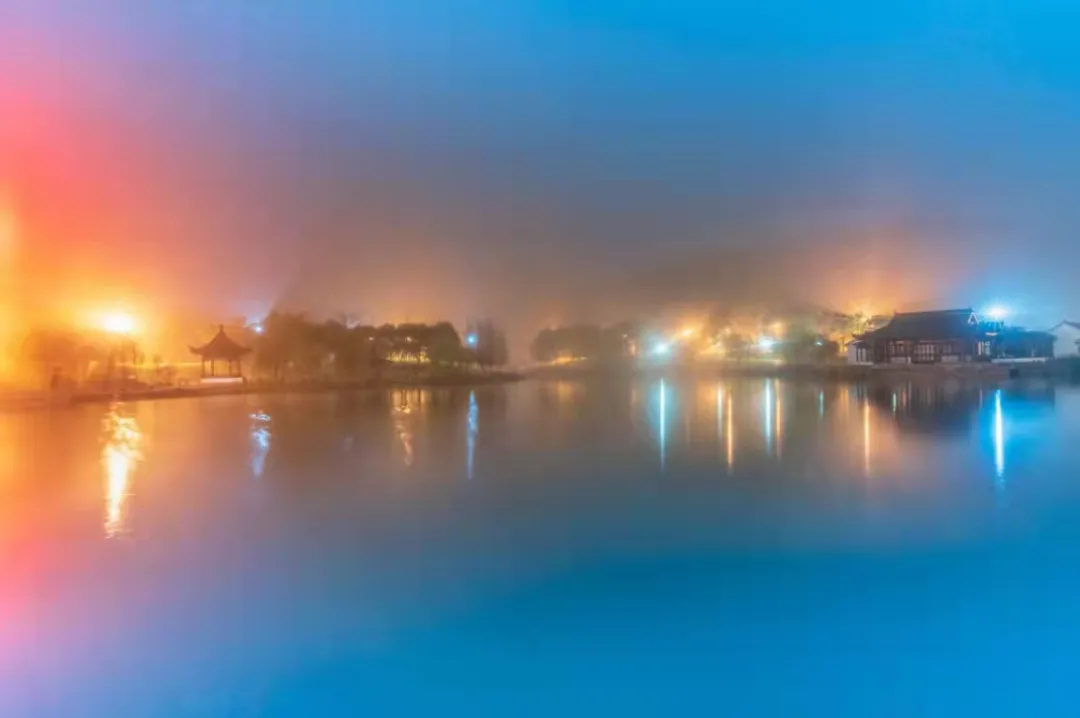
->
xmin=849 ymin=309 xmax=1000 ymax=364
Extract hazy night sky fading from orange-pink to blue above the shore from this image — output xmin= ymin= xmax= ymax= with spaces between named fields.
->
xmin=0 ymin=0 xmax=1080 ymax=330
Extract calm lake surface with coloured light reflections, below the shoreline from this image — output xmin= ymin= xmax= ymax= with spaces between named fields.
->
xmin=0 ymin=380 xmax=1080 ymax=718
